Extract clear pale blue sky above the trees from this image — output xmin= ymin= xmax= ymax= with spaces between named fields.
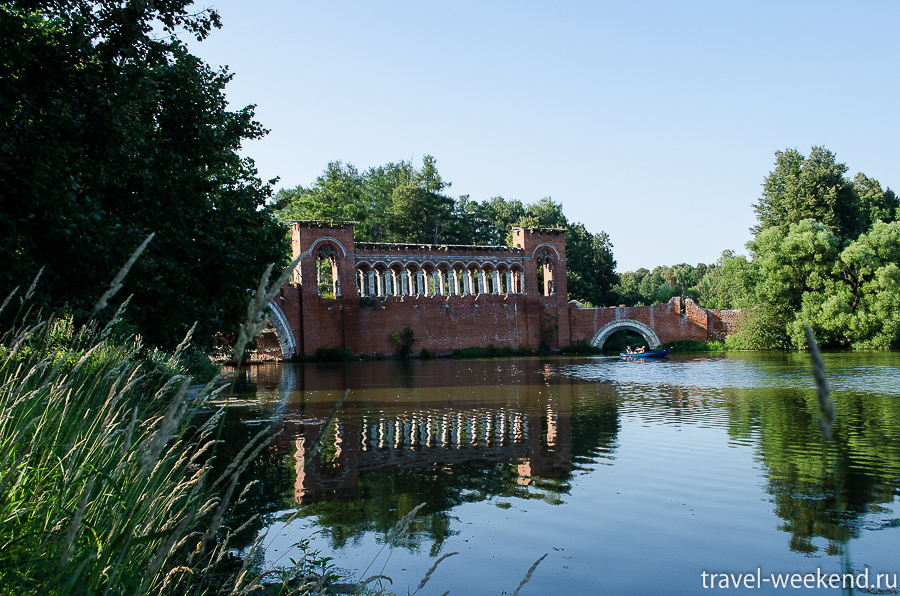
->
xmin=190 ymin=0 xmax=900 ymax=271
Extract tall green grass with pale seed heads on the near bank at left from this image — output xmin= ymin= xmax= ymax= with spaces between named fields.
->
xmin=0 ymin=318 xmax=240 ymax=594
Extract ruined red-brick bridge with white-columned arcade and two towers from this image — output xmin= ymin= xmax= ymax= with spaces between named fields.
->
xmin=269 ymin=221 xmax=739 ymax=357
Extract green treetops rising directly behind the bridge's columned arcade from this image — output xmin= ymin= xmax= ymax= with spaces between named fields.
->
xmin=276 ymin=155 xmax=616 ymax=306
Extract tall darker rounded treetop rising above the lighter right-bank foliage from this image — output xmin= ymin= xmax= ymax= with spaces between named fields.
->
xmin=751 ymin=146 xmax=865 ymax=240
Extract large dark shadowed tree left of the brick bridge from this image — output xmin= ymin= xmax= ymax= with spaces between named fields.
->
xmin=0 ymin=0 xmax=284 ymax=347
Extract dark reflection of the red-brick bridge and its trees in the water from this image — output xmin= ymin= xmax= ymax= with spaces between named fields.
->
xmin=222 ymin=360 xmax=618 ymax=552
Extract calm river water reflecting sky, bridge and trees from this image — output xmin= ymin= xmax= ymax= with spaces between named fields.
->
xmin=214 ymin=352 xmax=900 ymax=594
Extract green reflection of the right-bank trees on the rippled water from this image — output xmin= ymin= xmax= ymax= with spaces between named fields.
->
xmin=726 ymin=389 xmax=900 ymax=554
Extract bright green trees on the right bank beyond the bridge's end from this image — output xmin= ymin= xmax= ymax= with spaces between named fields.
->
xmin=614 ymin=147 xmax=900 ymax=349
